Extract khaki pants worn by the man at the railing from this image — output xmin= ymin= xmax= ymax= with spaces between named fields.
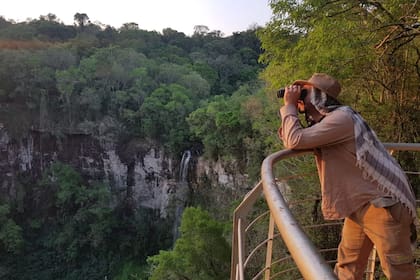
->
xmin=335 ymin=203 xmax=415 ymax=280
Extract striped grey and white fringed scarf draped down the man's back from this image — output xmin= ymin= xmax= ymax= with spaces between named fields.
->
xmin=310 ymin=92 xmax=417 ymax=220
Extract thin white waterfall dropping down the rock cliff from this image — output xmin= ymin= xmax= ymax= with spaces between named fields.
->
xmin=173 ymin=150 xmax=191 ymax=243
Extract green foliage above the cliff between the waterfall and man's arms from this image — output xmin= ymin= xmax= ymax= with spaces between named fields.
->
xmin=187 ymin=83 xmax=279 ymax=179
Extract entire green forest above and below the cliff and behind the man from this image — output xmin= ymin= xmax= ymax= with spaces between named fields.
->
xmin=0 ymin=0 xmax=420 ymax=280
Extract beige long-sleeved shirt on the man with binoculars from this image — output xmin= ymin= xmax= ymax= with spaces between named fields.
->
xmin=280 ymin=105 xmax=385 ymax=220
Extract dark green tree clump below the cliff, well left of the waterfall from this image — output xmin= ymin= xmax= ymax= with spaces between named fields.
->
xmin=40 ymin=163 xmax=116 ymax=262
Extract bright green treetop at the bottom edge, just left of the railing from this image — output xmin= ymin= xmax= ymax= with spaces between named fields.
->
xmin=148 ymin=207 xmax=230 ymax=280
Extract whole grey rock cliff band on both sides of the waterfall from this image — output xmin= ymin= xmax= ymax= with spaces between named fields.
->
xmin=0 ymin=126 xmax=246 ymax=217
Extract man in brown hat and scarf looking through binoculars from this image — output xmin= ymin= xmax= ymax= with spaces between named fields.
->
xmin=279 ymin=73 xmax=416 ymax=280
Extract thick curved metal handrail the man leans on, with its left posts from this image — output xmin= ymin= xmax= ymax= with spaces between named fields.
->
xmin=231 ymin=143 xmax=420 ymax=280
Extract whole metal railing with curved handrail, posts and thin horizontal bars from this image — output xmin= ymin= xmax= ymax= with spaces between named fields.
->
xmin=231 ymin=143 xmax=420 ymax=280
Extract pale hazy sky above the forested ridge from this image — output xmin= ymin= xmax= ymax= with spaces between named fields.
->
xmin=0 ymin=0 xmax=272 ymax=36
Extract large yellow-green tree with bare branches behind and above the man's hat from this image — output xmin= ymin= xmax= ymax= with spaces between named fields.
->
xmin=258 ymin=0 xmax=420 ymax=142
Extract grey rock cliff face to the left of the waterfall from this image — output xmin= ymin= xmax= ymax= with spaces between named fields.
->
xmin=0 ymin=126 xmax=172 ymax=214
